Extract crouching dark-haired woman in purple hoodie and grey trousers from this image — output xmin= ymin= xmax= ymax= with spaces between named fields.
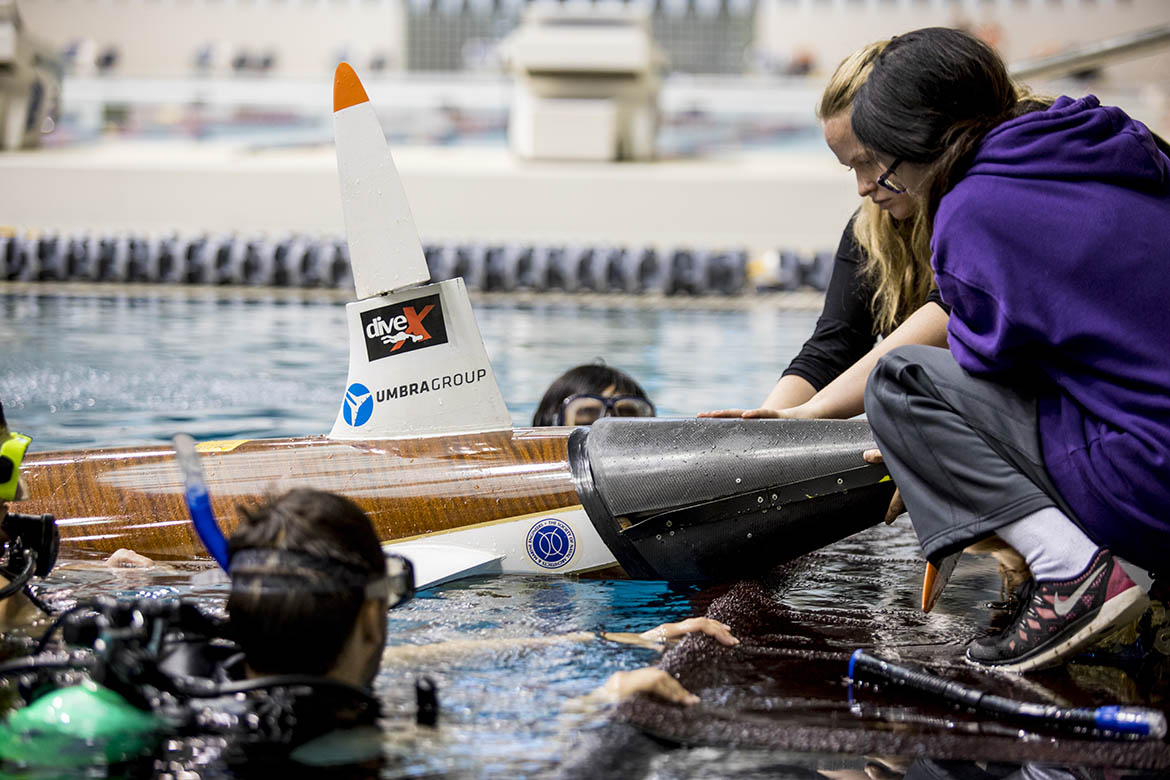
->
xmin=852 ymin=28 xmax=1170 ymax=671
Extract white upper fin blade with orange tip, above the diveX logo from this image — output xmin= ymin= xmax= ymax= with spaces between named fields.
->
xmin=333 ymin=62 xmax=431 ymax=301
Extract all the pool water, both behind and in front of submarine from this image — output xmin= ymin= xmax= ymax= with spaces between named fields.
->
xmin=0 ymin=290 xmax=1165 ymax=780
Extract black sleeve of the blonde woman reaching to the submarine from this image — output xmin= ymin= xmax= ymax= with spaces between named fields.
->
xmin=782 ymin=220 xmax=878 ymax=391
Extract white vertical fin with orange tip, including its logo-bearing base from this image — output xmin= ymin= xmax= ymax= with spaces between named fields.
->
xmin=329 ymin=62 xmax=511 ymax=439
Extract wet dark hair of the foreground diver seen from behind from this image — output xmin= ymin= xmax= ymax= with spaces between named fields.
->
xmin=227 ymin=488 xmax=386 ymax=675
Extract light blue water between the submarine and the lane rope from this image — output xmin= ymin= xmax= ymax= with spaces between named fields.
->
xmin=0 ymin=289 xmax=818 ymax=451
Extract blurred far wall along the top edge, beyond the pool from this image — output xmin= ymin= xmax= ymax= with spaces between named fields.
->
xmin=20 ymin=0 xmax=1170 ymax=83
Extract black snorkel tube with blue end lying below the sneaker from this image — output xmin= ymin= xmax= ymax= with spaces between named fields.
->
xmin=848 ymin=650 xmax=1166 ymax=739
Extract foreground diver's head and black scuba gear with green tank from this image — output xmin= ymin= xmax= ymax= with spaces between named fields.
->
xmin=0 ymin=489 xmax=414 ymax=768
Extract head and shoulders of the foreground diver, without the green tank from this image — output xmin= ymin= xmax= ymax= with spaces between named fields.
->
xmin=187 ymin=488 xmax=414 ymax=765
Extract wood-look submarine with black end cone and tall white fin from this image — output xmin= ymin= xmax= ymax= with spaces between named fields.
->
xmin=11 ymin=63 xmax=894 ymax=587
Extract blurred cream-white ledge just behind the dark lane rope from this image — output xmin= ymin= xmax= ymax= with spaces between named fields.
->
xmin=0 ymin=140 xmax=858 ymax=254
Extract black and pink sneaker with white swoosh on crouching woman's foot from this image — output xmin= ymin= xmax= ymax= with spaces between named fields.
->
xmin=966 ymin=548 xmax=1150 ymax=672
